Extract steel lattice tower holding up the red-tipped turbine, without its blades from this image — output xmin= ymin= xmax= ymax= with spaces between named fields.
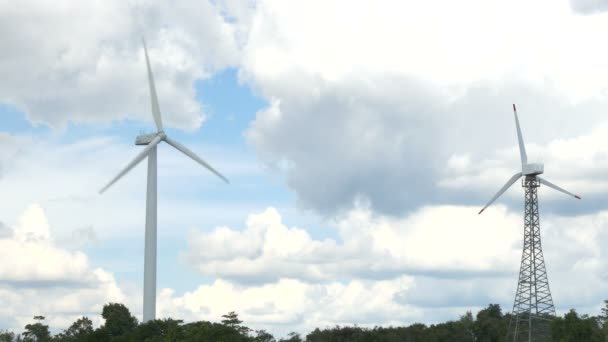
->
xmin=507 ymin=176 xmax=555 ymax=342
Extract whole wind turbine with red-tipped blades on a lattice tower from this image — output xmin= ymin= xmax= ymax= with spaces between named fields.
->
xmin=479 ymin=105 xmax=581 ymax=341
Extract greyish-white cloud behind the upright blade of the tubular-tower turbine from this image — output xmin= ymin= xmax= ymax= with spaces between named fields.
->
xmin=0 ymin=1 xmax=243 ymax=129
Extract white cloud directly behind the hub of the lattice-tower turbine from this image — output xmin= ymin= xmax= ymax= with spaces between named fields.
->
xmin=438 ymin=124 xmax=608 ymax=207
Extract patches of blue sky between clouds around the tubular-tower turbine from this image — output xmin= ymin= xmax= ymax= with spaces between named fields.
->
xmin=2 ymin=69 xmax=336 ymax=292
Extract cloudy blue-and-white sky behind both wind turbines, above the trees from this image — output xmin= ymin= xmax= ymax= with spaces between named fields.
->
xmin=0 ymin=0 xmax=608 ymax=336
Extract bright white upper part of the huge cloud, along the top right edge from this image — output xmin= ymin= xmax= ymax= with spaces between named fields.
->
xmin=244 ymin=0 xmax=608 ymax=99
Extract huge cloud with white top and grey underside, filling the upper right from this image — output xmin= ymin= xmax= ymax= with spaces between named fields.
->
xmin=241 ymin=1 xmax=608 ymax=216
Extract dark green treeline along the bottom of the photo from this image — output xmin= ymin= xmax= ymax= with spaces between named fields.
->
xmin=0 ymin=301 xmax=608 ymax=342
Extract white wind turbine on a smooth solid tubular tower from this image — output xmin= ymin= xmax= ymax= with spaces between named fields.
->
xmin=99 ymin=39 xmax=228 ymax=322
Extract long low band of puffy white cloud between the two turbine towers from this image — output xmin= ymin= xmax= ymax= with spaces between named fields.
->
xmin=185 ymin=206 xmax=519 ymax=283
